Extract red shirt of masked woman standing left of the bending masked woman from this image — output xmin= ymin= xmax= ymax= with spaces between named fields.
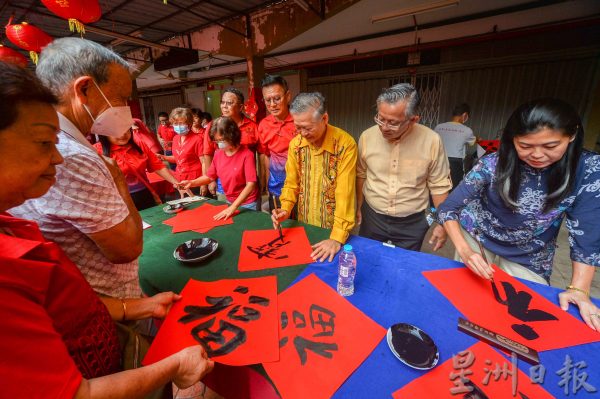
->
xmin=173 ymin=131 xmax=203 ymax=181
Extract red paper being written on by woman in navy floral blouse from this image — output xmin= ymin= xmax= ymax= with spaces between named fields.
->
xmin=423 ymin=265 xmax=600 ymax=351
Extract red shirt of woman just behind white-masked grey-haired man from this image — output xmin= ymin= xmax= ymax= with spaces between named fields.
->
xmin=94 ymin=142 xmax=166 ymax=192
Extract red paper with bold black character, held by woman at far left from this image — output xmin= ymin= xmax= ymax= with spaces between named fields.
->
xmin=142 ymin=276 xmax=279 ymax=366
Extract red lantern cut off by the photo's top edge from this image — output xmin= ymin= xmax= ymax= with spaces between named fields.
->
xmin=42 ymin=0 xmax=102 ymax=33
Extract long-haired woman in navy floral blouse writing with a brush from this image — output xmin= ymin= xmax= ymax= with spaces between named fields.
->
xmin=439 ymin=99 xmax=600 ymax=331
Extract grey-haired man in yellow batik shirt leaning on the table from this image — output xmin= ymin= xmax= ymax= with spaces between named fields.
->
xmin=272 ymin=92 xmax=357 ymax=262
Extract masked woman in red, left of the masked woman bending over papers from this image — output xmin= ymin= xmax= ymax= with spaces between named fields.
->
xmin=158 ymin=107 xmax=208 ymax=195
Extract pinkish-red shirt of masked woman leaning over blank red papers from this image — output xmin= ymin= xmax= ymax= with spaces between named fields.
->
xmin=206 ymin=146 xmax=258 ymax=204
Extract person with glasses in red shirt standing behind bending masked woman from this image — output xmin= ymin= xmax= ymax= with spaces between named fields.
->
xmin=204 ymin=87 xmax=258 ymax=201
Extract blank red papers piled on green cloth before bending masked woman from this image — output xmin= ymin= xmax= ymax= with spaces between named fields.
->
xmin=163 ymin=204 xmax=239 ymax=233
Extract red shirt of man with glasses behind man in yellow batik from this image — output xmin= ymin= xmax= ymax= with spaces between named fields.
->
xmin=258 ymin=114 xmax=296 ymax=158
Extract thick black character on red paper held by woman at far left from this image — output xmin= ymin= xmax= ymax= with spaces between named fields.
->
xmin=178 ymin=286 xmax=270 ymax=357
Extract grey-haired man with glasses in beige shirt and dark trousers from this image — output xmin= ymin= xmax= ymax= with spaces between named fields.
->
xmin=356 ymin=83 xmax=452 ymax=251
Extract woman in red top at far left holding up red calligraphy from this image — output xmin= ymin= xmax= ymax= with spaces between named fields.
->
xmin=0 ymin=62 xmax=213 ymax=398
